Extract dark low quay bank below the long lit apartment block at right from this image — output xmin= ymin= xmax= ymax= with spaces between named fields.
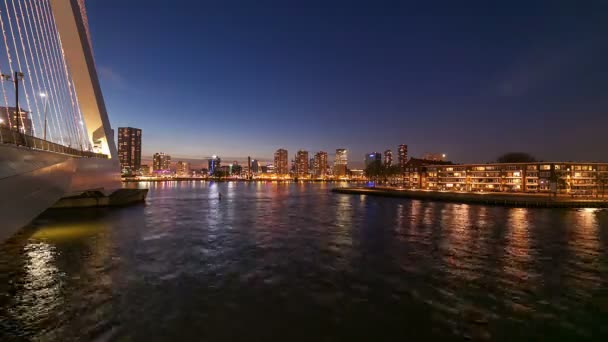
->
xmin=331 ymin=187 xmax=608 ymax=208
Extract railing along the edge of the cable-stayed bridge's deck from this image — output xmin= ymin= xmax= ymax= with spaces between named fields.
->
xmin=0 ymin=127 xmax=108 ymax=159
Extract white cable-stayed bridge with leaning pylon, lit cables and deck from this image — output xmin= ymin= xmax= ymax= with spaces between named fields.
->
xmin=0 ymin=0 xmax=120 ymax=241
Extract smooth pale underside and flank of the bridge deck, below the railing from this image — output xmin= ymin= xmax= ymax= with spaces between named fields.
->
xmin=0 ymin=144 xmax=120 ymax=241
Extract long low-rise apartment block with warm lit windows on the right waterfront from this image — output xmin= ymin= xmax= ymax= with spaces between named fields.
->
xmin=403 ymin=159 xmax=608 ymax=194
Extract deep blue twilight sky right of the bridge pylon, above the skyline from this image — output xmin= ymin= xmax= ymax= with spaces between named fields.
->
xmin=87 ymin=0 xmax=608 ymax=166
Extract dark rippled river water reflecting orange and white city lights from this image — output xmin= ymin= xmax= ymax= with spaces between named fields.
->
xmin=0 ymin=182 xmax=608 ymax=341
